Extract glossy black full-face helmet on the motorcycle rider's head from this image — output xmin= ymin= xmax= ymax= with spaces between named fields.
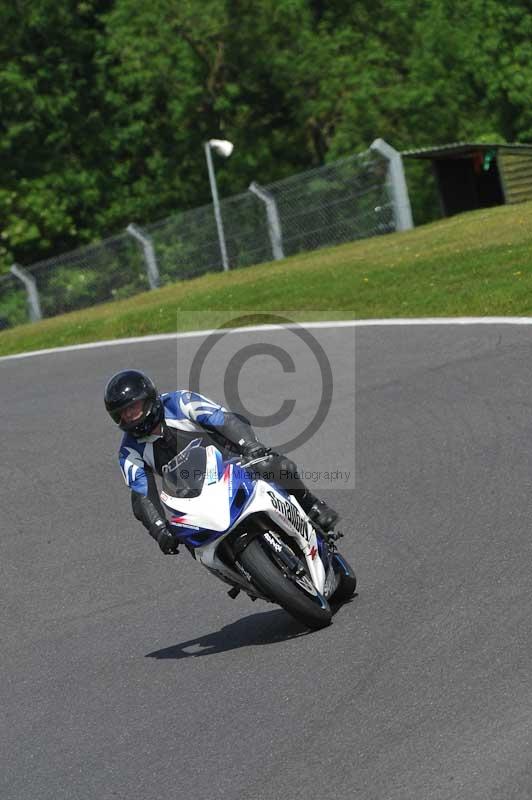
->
xmin=105 ymin=369 xmax=164 ymax=439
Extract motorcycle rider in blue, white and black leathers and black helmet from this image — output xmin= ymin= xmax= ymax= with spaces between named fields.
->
xmin=105 ymin=369 xmax=338 ymax=554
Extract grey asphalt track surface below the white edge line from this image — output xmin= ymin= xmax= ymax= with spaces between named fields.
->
xmin=0 ymin=325 xmax=532 ymax=800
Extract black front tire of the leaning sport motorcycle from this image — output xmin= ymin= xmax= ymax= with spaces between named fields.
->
xmin=239 ymin=539 xmax=332 ymax=630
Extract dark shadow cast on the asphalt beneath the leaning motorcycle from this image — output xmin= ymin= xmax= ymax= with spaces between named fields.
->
xmin=146 ymin=595 xmax=356 ymax=660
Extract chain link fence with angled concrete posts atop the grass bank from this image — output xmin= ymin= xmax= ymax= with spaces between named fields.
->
xmin=0 ymin=145 xmax=396 ymax=328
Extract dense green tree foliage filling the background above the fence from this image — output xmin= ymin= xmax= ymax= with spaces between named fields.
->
xmin=0 ymin=0 xmax=532 ymax=271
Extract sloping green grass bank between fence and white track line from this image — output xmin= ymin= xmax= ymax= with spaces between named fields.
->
xmin=0 ymin=202 xmax=532 ymax=355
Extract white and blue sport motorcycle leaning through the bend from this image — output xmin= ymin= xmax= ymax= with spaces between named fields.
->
xmin=160 ymin=439 xmax=356 ymax=629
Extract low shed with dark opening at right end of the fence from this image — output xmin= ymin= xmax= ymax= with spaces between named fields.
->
xmin=401 ymin=142 xmax=532 ymax=217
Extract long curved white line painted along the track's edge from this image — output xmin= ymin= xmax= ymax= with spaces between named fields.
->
xmin=0 ymin=317 xmax=532 ymax=361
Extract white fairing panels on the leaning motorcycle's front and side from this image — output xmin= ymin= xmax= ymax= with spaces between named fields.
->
xmin=161 ymin=447 xmax=326 ymax=596
